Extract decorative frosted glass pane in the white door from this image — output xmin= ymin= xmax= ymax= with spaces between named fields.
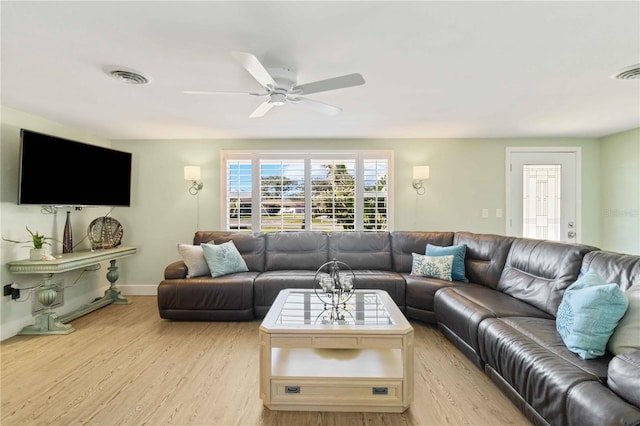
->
xmin=522 ymin=164 xmax=562 ymax=241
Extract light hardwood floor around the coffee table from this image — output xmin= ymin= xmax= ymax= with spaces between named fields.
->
xmin=0 ymin=296 xmax=530 ymax=426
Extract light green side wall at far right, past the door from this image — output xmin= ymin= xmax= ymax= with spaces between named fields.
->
xmin=600 ymin=129 xmax=640 ymax=254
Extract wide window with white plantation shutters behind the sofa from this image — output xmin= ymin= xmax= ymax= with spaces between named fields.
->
xmin=222 ymin=151 xmax=392 ymax=232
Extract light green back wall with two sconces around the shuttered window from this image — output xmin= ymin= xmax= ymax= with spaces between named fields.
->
xmin=107 ymin=139 xmax=600 ymax=292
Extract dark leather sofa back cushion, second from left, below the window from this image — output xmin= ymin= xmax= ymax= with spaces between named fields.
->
xmin=264 ymin=231 xmax=329 ymax=271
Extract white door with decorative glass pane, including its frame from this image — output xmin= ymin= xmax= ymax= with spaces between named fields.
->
xmin=506 ymin=147 xmax=581 ymax=242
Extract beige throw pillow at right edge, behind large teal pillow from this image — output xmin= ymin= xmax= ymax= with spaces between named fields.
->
xmin=607 ymin=285 xmax=640 ymax=355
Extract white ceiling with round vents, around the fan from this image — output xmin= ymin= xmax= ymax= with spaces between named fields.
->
xmin=0 ymin=1 xmax=640 ymax=139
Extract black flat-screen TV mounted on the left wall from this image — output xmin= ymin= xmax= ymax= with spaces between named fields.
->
xmin=18 ymin=129 xmax=132 ymax=206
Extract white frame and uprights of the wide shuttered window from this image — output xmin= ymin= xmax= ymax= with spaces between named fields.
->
xmin=220 ymin=150 xmax=394 ymax=232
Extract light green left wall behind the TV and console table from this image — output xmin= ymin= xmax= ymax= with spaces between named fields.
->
xmin=0 ymin=107 xmax=121 ymax=340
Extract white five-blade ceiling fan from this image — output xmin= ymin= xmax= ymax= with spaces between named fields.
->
xmin=184 ymin=52 xmax=364 ymax=118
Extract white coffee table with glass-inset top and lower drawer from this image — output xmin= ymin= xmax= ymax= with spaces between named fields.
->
xmin=260 ymin=289 xmax=413 ymax=413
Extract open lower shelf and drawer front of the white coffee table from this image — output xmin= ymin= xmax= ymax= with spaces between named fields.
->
xmin=263 ymin=348 xmax=407 ymax=413
